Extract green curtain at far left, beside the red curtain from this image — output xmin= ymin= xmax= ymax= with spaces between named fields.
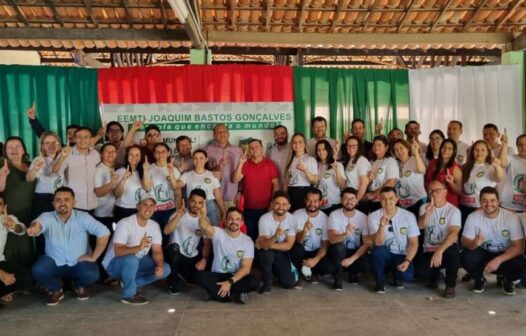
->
xmin=0 ymin=65 xmax=101 ymax=156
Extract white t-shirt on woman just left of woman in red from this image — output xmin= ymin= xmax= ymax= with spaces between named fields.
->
xmin=396 ymin=156 xmax=427 ymax=208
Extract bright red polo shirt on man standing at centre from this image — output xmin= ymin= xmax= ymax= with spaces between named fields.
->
xmin=241 ymin=158 xmax=279 ymax=209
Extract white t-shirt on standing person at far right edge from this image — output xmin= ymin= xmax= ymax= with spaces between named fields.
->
xmin=498 ymin=154 xmax=526 ymax=211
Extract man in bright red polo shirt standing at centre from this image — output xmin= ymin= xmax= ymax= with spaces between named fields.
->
xmin=232 ymin=139 xmax=279 ymax=241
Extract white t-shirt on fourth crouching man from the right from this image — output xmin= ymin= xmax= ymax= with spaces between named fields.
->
xmin=328 ymin=209 xmax=369 ymax=250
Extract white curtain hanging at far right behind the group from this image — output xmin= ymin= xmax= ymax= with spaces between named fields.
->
xmin=409 ymin=65 xmax=523 ymax=147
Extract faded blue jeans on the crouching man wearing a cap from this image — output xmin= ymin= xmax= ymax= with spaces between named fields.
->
xmin=106 ymin=254 xmax=170 ymax=299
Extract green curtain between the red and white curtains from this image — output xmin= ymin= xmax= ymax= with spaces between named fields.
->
xmin=294 ymin=67 xmax=409 ymax=140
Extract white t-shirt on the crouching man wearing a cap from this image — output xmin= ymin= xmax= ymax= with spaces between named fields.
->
xmin=102 ymin=215 xmax=163 ymax=269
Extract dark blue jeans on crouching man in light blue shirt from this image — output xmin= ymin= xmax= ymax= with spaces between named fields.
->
xmin=31 ymin=256 xmax=99 ymax=292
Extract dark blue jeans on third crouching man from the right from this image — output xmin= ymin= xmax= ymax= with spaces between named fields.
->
xmin=371 ymin=246 xmax=414 ymax=285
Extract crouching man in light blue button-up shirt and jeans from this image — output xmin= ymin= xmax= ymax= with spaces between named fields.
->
xmin=27 ymin=187 xmax=110 ymax=306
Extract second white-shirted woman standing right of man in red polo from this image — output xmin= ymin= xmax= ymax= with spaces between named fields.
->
xmin=316 ymin=140 xmax=345 ymax=216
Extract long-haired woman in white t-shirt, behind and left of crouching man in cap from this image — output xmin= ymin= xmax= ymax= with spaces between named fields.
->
xmin=113 ymin=145 xmax=152 ymax=223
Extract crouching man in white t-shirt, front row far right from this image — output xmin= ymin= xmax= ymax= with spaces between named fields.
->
xmin=461 ymin=187 xmax=526 ymax=295
